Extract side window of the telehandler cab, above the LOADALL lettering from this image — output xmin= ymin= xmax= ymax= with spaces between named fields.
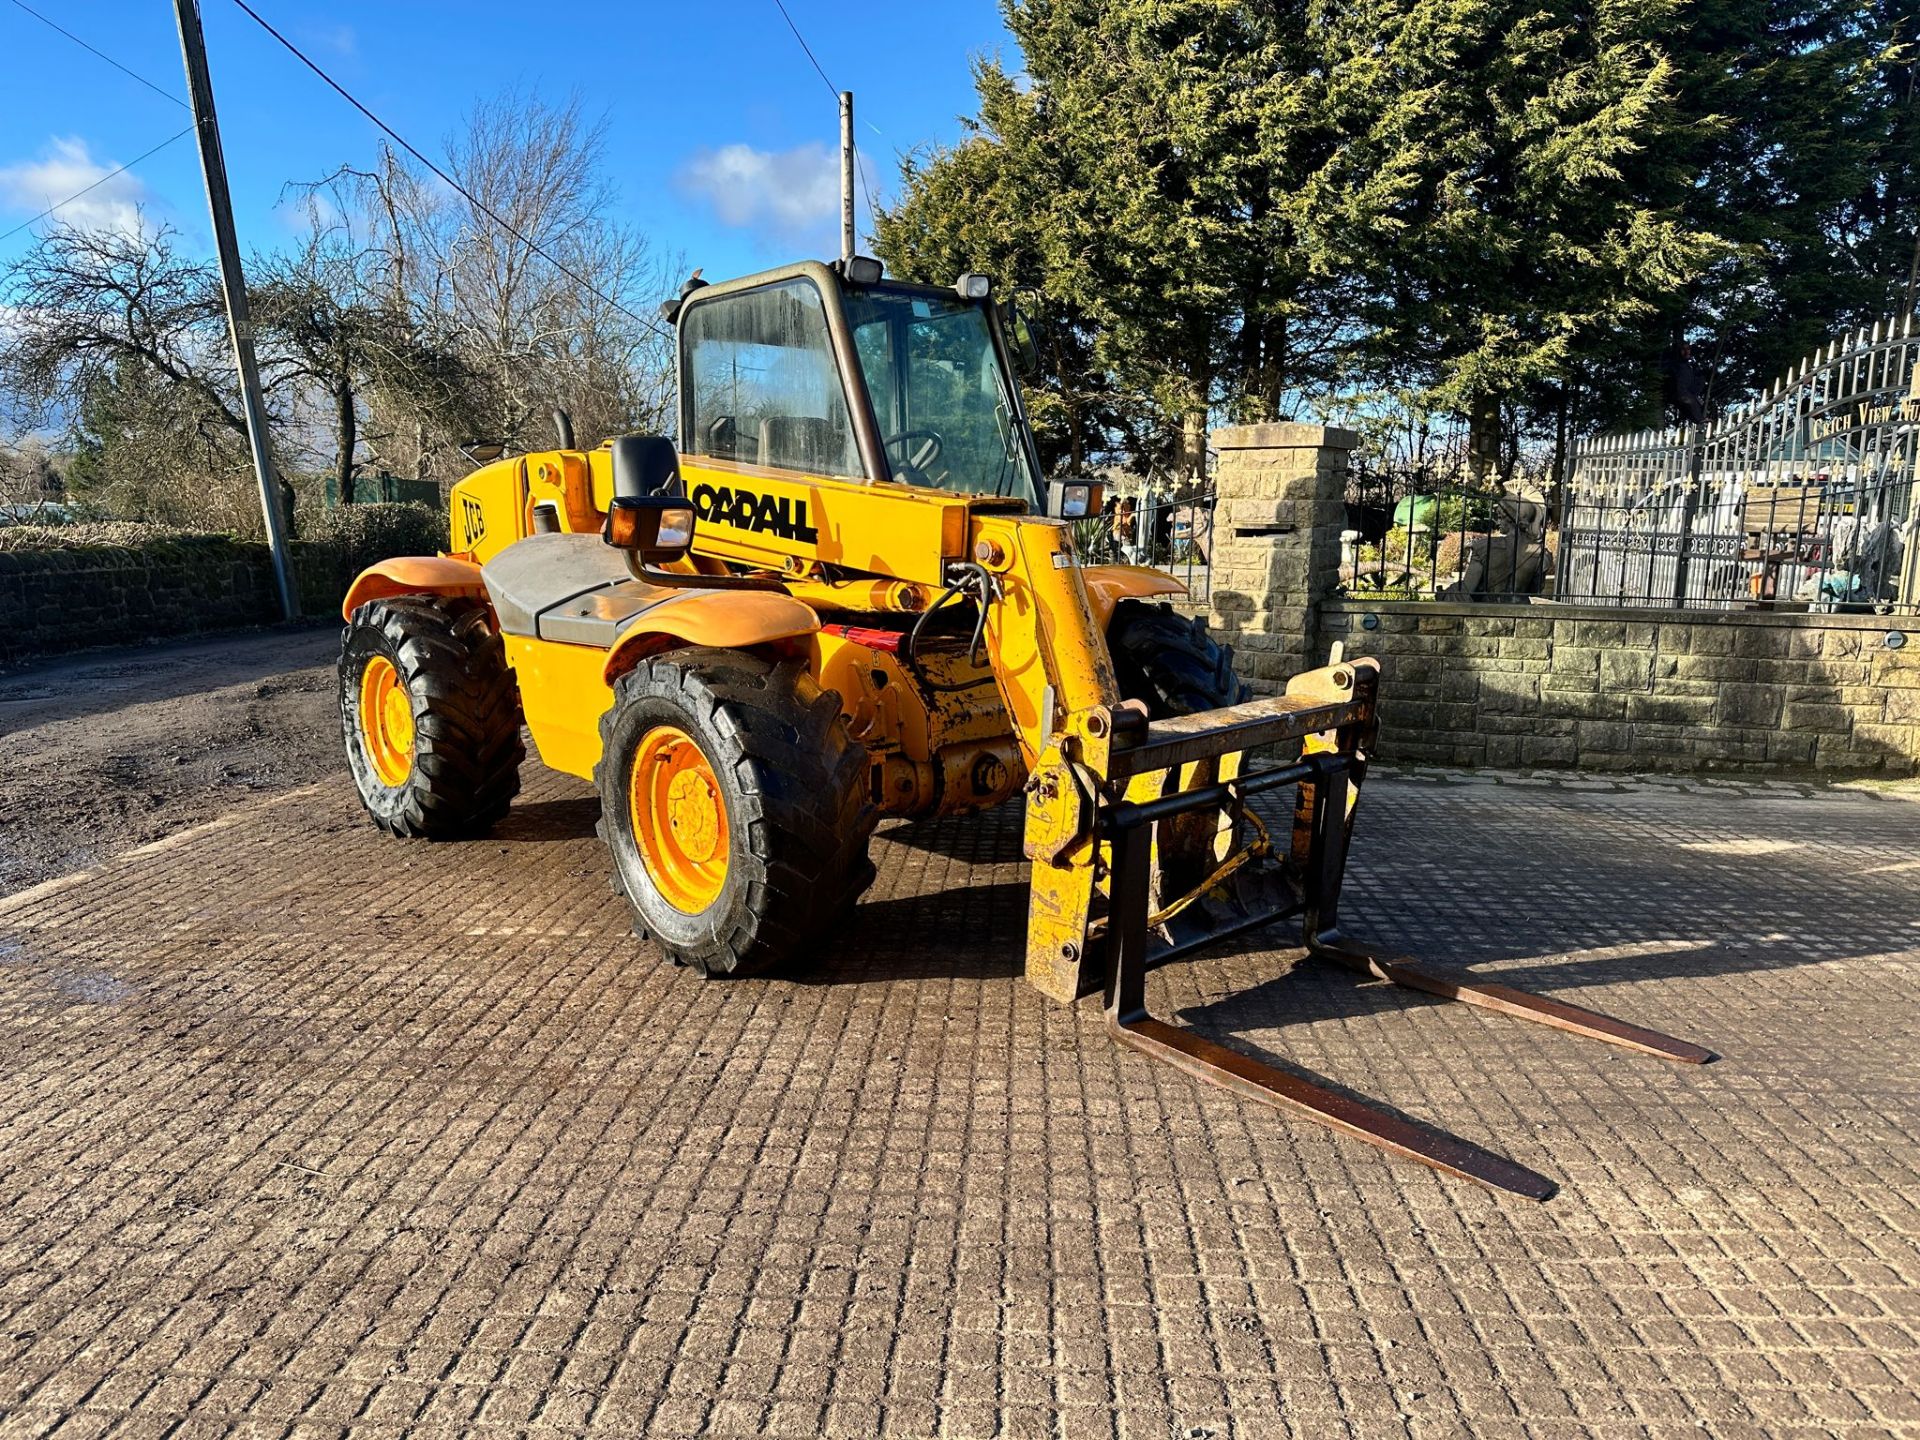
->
xmin=680 ymin=280 xmax=866 ymax=478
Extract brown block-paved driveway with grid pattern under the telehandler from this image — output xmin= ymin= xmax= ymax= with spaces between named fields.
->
xmin=0 ymin=770 xmax=1920 ymax=1440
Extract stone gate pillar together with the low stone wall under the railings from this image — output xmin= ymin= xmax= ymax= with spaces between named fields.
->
xmin=1210 ymin=424 xmax=1920 ymax=774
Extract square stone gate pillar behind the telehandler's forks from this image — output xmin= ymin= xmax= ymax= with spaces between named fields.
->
xmin=1210 ymin=422 xmax=1359 ymax=695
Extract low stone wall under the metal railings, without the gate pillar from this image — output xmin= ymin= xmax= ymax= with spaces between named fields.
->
xmin=1317 ymin=603 xmax=1920 ymax=774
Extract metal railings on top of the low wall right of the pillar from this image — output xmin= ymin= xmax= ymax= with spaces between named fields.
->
xmin=1342 ymin=319 xmax=1920 ymax=612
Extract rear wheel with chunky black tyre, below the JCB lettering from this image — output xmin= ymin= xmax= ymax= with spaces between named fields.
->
xmin=340 ymin=595 xmax=526 ymax=839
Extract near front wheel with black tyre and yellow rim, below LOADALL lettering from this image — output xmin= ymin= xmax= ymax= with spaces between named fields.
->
xmin=593 ymin=649 xmax=876 ymax=975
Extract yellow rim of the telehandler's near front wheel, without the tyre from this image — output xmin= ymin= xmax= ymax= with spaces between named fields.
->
xmin=628 ymin=726 xmax=728 ymax=916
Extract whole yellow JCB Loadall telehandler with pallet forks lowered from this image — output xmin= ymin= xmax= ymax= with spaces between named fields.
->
xmin=340 ymin=257 xmax=1707 ymax=1198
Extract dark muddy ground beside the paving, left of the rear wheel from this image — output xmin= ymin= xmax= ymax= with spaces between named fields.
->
xmin=0 ymin=626 xmax=344 ymax=895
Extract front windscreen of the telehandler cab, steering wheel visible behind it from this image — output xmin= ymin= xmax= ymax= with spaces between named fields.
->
xmin=847 ymin=290 xmax=1039 ymax=509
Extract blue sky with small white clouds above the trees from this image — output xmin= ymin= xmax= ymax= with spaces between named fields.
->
xmin=0 ymin=0 xmax=1018 ymax=278
